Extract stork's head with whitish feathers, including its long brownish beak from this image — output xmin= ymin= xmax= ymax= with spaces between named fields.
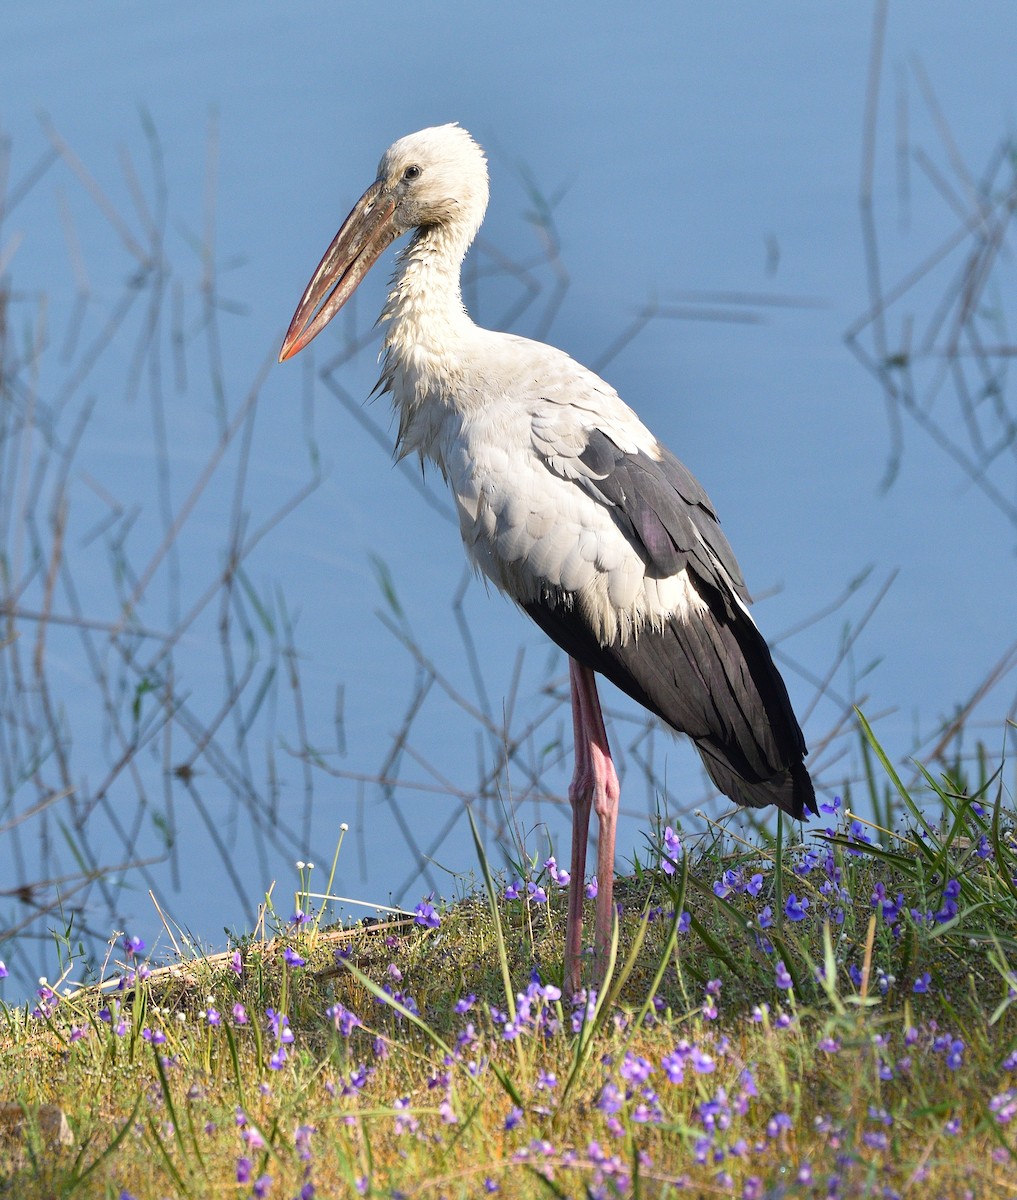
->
xmin=279 ymin=125 xmax=488 ymax=362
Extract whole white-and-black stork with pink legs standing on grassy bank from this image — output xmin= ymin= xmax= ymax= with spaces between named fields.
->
xmin=279 ymin=125 xmax=817 ymax=991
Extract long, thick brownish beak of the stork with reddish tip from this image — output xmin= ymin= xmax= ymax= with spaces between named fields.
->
xmin=279 ymin=179 xmax=399 ymax=362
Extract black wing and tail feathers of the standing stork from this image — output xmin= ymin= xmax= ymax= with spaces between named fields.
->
xmin=537 ymin=431 xmax=817 ymax=817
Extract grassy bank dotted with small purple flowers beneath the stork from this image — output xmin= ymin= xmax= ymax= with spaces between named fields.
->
xmin=0 ymin=734 xmax=1017 ymax=1200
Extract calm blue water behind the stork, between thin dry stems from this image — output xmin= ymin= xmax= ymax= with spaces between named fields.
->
xmin=0 ymin=0 xmax=1017 ymax=998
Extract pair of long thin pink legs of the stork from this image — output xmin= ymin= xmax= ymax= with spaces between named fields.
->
xmin=565 ymin=659 xmax=621 ymax=992
